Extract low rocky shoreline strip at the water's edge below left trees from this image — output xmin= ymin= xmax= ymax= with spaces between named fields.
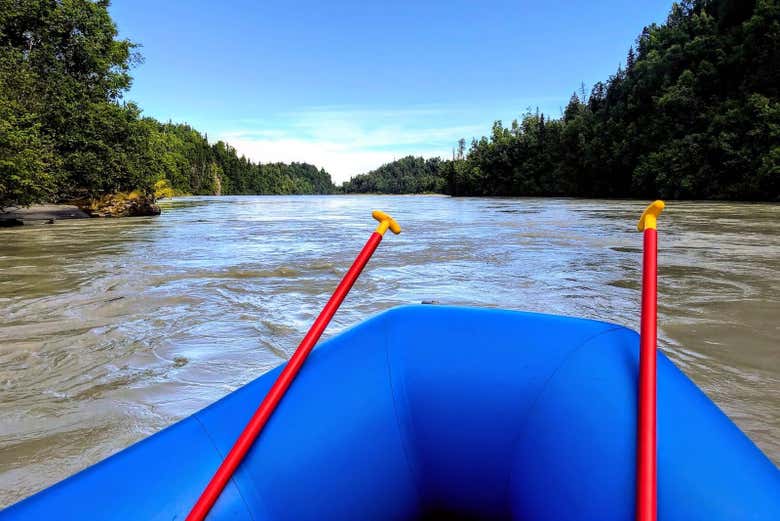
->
xmin=0 ymin=192 xmax=160 ymax=224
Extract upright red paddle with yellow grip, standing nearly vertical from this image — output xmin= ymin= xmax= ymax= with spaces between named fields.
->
xmin=636 ymin=201 xmax=665 ymax=521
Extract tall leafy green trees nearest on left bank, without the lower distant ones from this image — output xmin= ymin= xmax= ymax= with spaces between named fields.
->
xmin=0 ymin=0 xmax=148 ymax=204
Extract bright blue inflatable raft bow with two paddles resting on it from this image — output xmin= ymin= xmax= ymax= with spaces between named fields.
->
xmin=0 ymin=306 xmax=780 ymax=521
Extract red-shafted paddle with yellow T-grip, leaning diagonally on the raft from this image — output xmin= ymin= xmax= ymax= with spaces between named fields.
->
xmin=187 ymin=210 xmax=401 ymax=521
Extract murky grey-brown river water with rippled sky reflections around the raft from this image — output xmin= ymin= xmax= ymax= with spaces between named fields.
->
xmin=0 ymin=196 xmax=780 ymax=506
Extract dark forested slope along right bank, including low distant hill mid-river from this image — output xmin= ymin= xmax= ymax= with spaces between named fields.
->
xmin=344 ymin=0 xmax=780 ymax=201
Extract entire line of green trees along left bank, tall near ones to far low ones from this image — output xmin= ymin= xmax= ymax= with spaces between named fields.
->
xmin=0 ymin=0 xmax=334 ymax=208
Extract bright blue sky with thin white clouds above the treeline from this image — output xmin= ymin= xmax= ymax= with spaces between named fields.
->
xmin=111 ymin=0 xmax=671 ymax=182
